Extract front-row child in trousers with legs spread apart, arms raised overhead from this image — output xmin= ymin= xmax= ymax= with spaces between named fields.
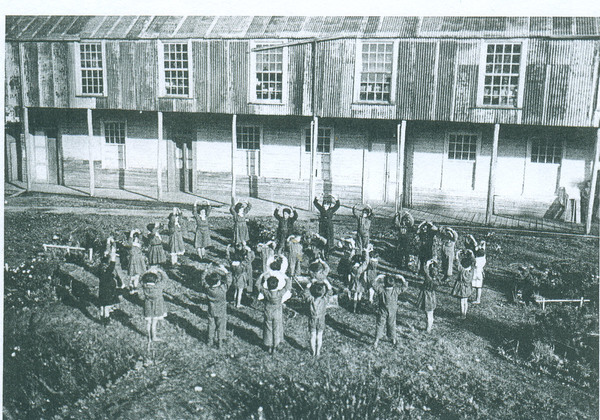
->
xmin=372 ymin=274 xmax=408 ymax=348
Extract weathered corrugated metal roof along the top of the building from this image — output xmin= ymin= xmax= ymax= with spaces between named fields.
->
xmin=6 ymin=16 xmax=600 ymax=41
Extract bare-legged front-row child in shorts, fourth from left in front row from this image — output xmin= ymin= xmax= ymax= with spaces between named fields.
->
xmin=304 ymin=279 xmax=332 ymax=357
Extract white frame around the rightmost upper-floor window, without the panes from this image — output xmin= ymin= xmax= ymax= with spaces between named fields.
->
xmin=476 ymin=38 xmax=529 ymax=109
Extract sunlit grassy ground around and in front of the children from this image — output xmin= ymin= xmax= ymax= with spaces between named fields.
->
xmin=4 ymin=199 xmax=598 ymax=418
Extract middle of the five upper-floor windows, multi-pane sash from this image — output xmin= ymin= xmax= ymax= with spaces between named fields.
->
xmin=251 ymin=43 xmax=286 ymax=102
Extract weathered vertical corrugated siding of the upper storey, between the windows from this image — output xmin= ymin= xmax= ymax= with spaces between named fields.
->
xmin=6 ymin=39 xmax=600 ymax=126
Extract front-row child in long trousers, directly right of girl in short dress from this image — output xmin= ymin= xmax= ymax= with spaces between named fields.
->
xmin=202 ymin=265 xmax=232 ymax=348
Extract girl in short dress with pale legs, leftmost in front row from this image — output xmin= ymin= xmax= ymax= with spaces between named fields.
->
xmin=141 ymin=266 xmax=168 ymax=345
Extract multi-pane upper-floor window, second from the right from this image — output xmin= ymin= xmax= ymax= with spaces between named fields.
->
xmin=355 ymin=41 xmax=396 ymax=103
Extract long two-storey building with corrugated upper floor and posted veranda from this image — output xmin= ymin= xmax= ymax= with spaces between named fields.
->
xmin=6 ymin=16 xmax=600 ymax=231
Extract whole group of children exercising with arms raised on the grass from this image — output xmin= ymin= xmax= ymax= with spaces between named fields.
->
xmin=95 ymin=196 xmax=485 ymax=356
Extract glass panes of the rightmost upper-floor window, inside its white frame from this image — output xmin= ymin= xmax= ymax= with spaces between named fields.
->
xmin=479 ymin=42 xmax=523 ymax=107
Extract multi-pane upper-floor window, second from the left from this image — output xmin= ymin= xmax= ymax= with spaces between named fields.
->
xmin=162 ymin=42 xmax=191 ymax=96
